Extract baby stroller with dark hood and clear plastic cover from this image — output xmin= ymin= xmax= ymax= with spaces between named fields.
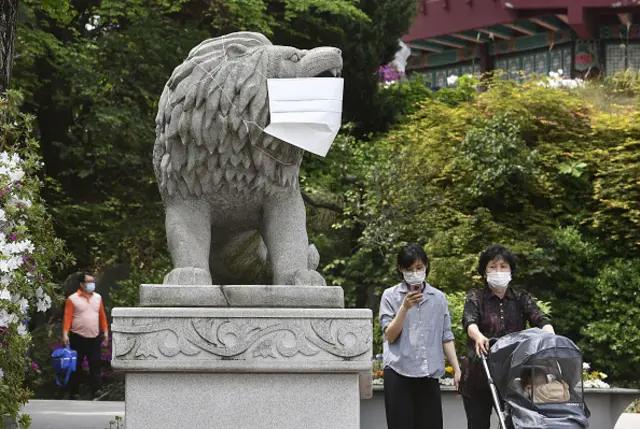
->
xmin=482 ymin=328 xmax=590 ymax=429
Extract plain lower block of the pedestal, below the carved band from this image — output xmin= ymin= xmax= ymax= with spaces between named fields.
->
xmin=125 ymin=373 xmax=360 ymax=429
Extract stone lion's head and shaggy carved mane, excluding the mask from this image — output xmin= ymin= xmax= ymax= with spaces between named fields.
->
xmin=153 ymin=32 xmax=342 ymax=197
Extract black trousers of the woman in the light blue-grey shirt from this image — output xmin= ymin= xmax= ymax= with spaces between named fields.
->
xmin=384 ymin=368 xmax=442 ymax=429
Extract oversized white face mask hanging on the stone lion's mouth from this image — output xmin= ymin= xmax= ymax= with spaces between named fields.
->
xmin=264 ymin=77 xmax=344 ymax=156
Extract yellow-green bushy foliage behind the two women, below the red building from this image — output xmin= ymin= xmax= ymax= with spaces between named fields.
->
xmin=308 ymin=72 xmax=640 ymax=382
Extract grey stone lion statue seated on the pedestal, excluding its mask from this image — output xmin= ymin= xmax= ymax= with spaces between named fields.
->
xmin=153 ymin=32 xmax=342 ymax=285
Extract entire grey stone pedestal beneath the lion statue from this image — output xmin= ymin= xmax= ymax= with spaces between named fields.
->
xmin=112 ymin=285 xmax=372 ymax=429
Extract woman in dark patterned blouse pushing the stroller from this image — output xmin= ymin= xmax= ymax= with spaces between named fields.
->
xmin=460 ymin=244 xmax=554 ymax=429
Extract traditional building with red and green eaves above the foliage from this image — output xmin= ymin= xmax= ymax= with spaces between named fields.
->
xmin=402 ymin=0 xmax=640 ymax=88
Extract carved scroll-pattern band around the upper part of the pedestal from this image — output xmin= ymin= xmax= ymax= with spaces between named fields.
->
xmin=113 ymin=318 xmax=372 ymax=360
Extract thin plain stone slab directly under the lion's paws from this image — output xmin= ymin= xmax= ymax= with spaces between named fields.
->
xmin=140 ymin=284 xmax=344 ymax=308
